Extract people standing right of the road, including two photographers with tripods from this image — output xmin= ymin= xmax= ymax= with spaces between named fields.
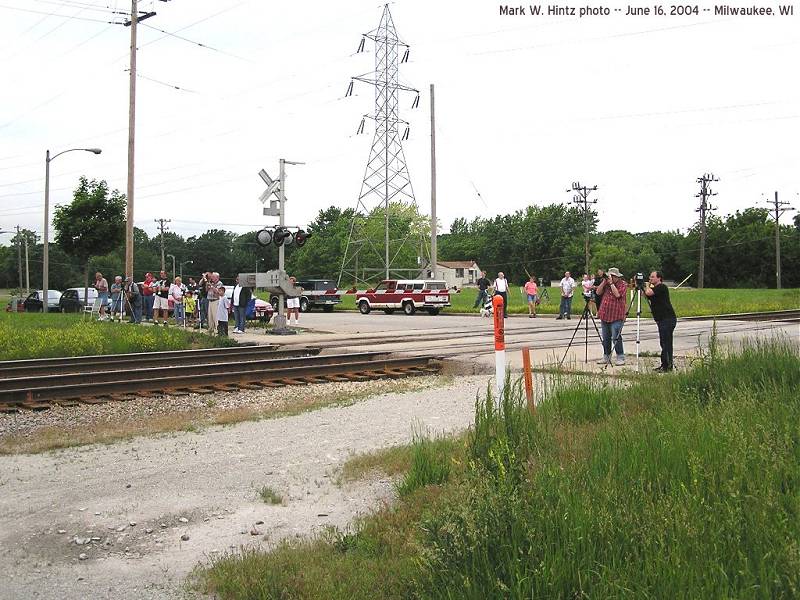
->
xmin=466 ymin=267 xmax=677 ymax=372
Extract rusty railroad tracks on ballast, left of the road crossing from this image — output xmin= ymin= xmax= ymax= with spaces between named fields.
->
xmin=0 ymin=347 xmax=441 ymax=412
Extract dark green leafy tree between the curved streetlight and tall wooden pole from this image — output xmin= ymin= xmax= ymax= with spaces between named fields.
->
xmin=53 ymin=177 xmax=125 ymax=302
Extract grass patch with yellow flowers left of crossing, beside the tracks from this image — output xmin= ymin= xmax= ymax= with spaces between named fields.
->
xmin=0 ymin=312 xmax=236 ymax=360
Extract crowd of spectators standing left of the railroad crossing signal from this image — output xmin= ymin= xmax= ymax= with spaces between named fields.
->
xmin=93 ymin=271 xmax=253 ymax=336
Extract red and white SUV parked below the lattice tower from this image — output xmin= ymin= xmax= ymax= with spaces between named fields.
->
xmin=356 ymin=279 xmax=450 ymax=315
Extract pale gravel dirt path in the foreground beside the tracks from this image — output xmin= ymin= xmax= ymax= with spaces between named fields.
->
xmin=0 ymin=376 xmax=486 ymax=600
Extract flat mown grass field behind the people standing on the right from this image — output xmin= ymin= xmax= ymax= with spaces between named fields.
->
xmin=298 ymin=286 xmax=800 ymax=318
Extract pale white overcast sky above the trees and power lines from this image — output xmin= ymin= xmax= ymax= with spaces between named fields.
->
xmin=0 ymin=0 xmax=800 ymax=243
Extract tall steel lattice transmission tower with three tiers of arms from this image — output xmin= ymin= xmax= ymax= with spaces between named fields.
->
xmin=339 ymin=4 xmax=429 ymax=284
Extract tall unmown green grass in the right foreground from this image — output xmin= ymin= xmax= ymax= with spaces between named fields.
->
xmin=199 ymin=342 xmax=800 ymax=599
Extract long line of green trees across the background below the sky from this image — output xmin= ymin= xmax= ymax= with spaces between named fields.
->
xmin=0 ymin=178 xmax=800 ymax=289
